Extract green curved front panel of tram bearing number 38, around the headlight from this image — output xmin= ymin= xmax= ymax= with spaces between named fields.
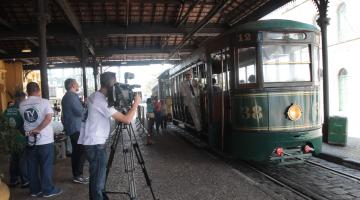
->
xmin=232 ymin=91 xmax=321 ymax=132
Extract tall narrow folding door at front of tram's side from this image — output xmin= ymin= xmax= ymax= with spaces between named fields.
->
xmin=208 ymin=48 xmax=231 ymax=152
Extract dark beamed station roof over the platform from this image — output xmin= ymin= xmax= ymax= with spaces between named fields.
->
xmin=0 ymin=0 xmax=291 ymax=69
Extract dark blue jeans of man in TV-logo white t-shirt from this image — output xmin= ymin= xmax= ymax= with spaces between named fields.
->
xmin=26 ymin=143 xmax=56 ymax=195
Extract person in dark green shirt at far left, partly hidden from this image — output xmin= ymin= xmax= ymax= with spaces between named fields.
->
xmin=4 ymin=92 xmax=29 ymax=188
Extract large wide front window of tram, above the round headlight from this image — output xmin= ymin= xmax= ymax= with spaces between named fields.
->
xmin=262 ymin=45 xmax=311 ymax=82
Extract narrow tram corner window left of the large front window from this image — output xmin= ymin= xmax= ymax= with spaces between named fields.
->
xmin=238 ymin=47 xmax=256 ymax=85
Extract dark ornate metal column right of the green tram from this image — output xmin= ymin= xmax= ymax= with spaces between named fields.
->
xmin=313 ymin=0 xmax=330 ymax=142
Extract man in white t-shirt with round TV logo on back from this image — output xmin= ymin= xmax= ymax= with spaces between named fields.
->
xmin=19 ymin=82 xmax=62 ymax=197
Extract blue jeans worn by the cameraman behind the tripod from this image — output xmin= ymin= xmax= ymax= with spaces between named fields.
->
xmin=84 ymin=144 xmax=108 ymax=200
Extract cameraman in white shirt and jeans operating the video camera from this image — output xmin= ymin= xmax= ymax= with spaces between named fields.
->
xmin=78 ymin=72 xmax=141 ymax=200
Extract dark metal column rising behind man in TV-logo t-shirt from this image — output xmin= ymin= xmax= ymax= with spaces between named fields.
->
xmin=37 ymin=0 xmax=49 ymax=99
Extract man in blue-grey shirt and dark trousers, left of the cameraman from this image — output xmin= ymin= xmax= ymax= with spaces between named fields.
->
xmin=61 ymin=78 xmax=88 ymax=184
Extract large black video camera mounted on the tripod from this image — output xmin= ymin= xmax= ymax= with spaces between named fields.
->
xmin=108 ymin=72 xmax=141 ymax=111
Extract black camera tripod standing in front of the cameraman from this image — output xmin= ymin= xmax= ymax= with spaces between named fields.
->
xmin=105 ymin=123 xmax=158 ymax=200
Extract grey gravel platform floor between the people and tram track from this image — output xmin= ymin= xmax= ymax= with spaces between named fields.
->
xmin=0 ymin=126 xmax=272 ymax=200
